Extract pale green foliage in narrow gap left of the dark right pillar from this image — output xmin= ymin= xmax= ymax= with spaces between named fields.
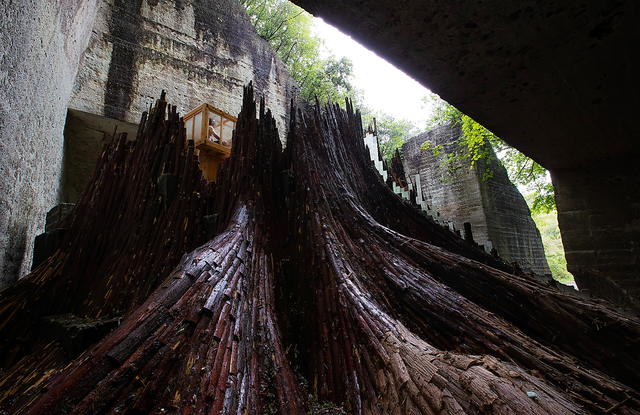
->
xmin=527 ymin=210 xmax=573 ymax=284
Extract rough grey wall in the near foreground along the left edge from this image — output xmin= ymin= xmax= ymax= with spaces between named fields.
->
xmin=0 ymin=0 xmax=96 ymax=288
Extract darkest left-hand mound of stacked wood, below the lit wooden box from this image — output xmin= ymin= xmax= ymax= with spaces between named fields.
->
xmin=0 ymin=93 xmax=210 ymax=412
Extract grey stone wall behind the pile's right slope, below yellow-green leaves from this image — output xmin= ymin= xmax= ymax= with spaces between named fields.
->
xmin=402 ymin=126 xmax=550 ymax=274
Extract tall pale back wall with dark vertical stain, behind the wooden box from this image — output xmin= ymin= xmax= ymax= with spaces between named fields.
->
xmin=70 ymin=0 xmax=295 ymax=137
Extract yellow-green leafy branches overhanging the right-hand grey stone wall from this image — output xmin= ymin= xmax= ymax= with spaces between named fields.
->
xmin=422 ymin=94 xmax=555 ymax=214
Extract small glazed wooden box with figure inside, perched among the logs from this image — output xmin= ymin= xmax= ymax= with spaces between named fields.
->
xmin=183 ymin=104 xmax=237 ymax=182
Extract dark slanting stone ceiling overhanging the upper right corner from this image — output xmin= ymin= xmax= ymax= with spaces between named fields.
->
xmin=294 ymin=0 xmax=640 ymax=170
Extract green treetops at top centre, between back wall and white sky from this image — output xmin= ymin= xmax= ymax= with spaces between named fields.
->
xmin=240 ymin=0 xmax=360 ymax=104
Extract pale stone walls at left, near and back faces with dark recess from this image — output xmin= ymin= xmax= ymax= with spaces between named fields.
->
xmin=0 ymin=0 xmax=297 ymax=288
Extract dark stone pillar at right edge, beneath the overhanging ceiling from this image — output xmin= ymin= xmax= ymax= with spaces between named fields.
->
xmin=552 ymin=158 xmax=640 ymax=313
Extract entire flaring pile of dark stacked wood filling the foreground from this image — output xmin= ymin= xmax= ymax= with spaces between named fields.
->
xmin=0 ymin=86 xmax=640 ymax=414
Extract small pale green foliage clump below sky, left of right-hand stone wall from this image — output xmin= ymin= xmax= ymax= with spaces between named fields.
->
xmin=362 ymin=108 xmax=417 ymax=160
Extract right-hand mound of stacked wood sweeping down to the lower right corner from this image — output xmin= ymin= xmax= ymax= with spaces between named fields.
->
xmin=279 ymin=96 xmax=640 ymax=413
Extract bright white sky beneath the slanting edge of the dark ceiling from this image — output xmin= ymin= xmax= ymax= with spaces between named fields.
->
xmin=314 ymin=19 xmax=430 ymax=131
